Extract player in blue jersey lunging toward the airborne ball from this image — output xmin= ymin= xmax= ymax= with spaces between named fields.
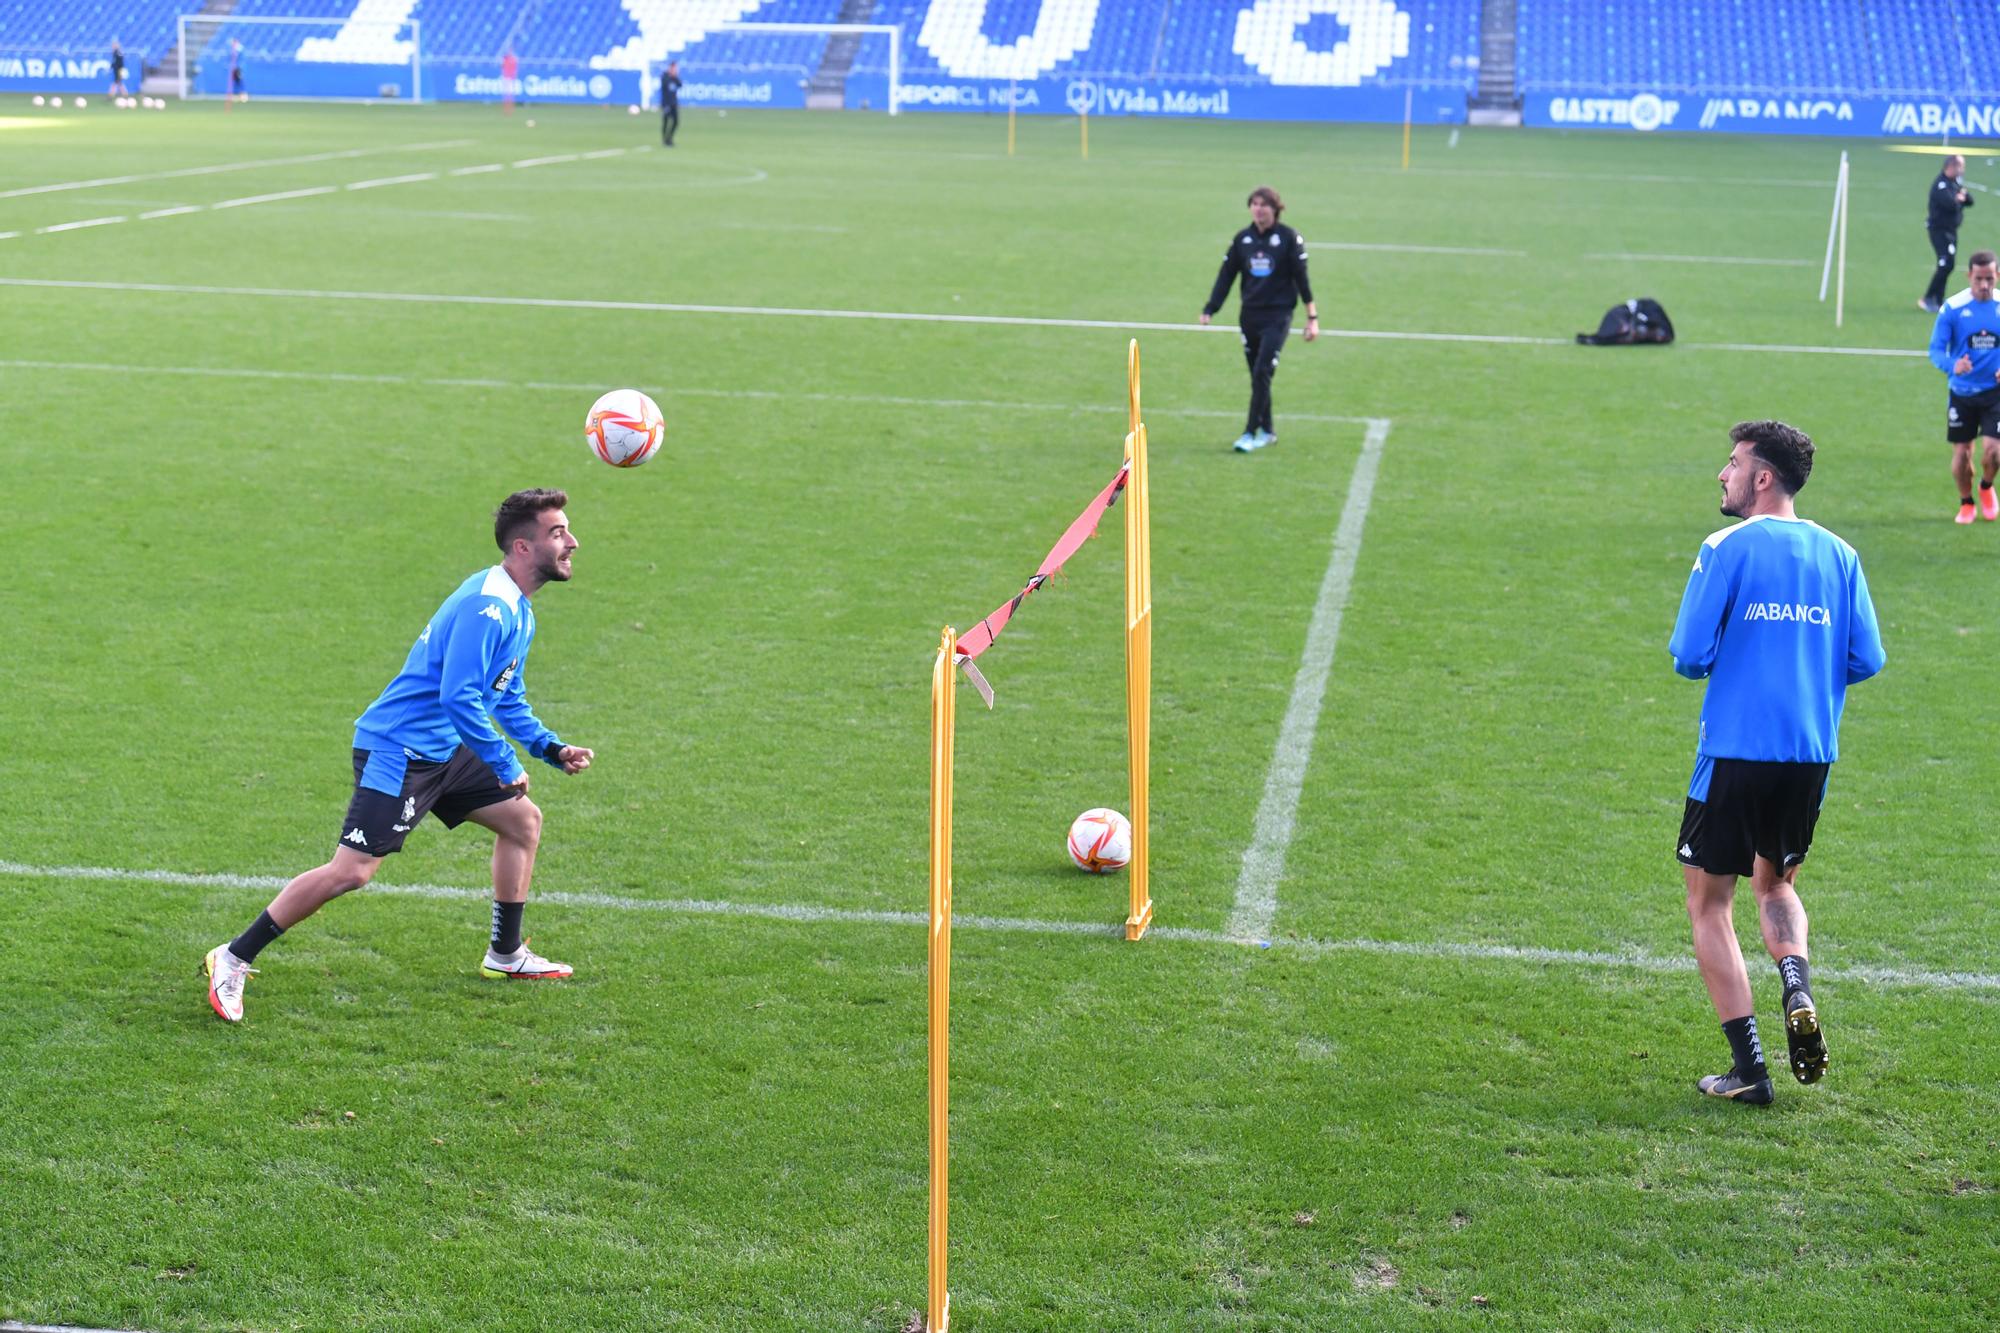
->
xmin=202 ymin=490 xmax=594 ymax=1023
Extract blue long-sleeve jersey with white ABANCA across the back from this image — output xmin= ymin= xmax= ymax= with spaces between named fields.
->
xmin=1668 ymin=514 xmax=1884 ymax=784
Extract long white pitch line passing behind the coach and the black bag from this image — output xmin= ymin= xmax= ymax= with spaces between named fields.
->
xmin=0 ymin=278 xmax=1928 ymax=358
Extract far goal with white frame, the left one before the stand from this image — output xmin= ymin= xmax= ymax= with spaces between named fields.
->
xmin=168 ymin=14 xmax=424 ymax=102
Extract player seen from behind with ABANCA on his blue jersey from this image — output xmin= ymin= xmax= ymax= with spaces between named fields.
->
xmin=1668 ymin=420 xmax=1884 ymax=1105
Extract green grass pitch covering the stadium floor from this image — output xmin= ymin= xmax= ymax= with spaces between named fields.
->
xmin=0 ymin=98 xmax=2000 ymax=1331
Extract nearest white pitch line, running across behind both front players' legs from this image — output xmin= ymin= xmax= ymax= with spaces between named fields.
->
xmin=0 ymin=861 xmax=2000 ymax=993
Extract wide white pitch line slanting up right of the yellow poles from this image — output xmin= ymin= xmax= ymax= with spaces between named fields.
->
xmin=1230 ymin=420 xmax=1388 ymax=943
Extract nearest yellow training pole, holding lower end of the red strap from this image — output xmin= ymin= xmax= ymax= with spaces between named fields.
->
xmin=924 ymin=626 xmax=958 ymax=1333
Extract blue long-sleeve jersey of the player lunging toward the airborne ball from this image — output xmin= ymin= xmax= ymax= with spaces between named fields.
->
xmin=354 ymin=564 xmax=562 ymax=795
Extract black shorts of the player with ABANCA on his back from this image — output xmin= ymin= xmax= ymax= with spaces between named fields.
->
xmin=1676 ymin=759 xmax=1830 ymax=875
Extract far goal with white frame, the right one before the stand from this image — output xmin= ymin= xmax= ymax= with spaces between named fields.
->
xmin=636 ymin=22 xmax=902 ymax=116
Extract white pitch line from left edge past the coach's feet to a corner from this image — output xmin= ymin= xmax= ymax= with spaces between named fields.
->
xmin=0 ymin=360 xmax=1374 ymax=424
